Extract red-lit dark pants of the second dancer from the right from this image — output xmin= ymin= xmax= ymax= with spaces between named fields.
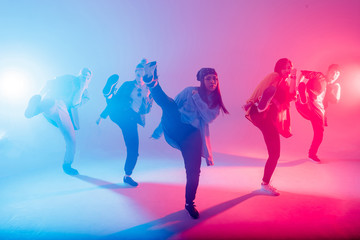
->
xmin=250 ymin=105 xmax=280 ymax=183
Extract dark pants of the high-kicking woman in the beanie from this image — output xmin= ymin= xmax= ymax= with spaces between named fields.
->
xmin=150 ymin=84 xmax=202 ymax=204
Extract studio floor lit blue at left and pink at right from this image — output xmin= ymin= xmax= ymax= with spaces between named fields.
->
xmin=0 ymin=151 xmax=360 ymax=239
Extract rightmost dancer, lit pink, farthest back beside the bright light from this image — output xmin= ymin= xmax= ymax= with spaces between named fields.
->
xmin=295 ymin=64 xmax=341 ymax=163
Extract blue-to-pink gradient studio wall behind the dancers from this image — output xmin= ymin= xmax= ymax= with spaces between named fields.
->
xmin=0 ymin=0 xmax=360 ymax=172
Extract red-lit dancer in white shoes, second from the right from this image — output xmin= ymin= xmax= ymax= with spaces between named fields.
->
xmin=244 ymin=58 xmax=296 ymax=196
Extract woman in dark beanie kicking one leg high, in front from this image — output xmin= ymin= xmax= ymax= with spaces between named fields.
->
xmin=144 ymin=62 xmax=228 ymax=219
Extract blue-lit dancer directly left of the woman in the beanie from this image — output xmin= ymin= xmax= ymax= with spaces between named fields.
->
xmin=96 ymin=59 xmax=153 ymax=187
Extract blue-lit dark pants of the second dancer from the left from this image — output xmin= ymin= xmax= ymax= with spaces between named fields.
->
xmin=110 ymin=111 xmax=139 ymax=175
